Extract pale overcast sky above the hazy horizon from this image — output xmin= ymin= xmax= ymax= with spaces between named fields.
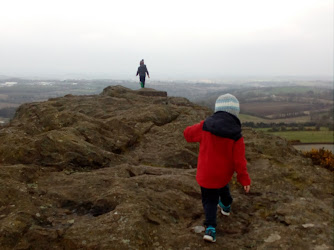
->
xmin=0 ymin=0 xmax=333 ymax=80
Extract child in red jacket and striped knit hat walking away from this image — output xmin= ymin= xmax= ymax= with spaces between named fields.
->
xmin=183 ymin=94 xmax=251 ymax=242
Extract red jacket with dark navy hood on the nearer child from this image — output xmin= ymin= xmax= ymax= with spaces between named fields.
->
xmin=183 ymin=111 xmax=251 ymax=188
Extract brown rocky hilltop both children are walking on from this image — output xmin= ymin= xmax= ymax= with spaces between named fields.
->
xmin=0 ymin=86 xmax=333 ymax=249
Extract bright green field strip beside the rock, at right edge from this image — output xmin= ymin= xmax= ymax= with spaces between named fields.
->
xmin=256 ymin=129 xmax=334 ymax=143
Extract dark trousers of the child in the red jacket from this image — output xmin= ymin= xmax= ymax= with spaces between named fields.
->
xmin=201 ymin=184 xmax=233 ymax=227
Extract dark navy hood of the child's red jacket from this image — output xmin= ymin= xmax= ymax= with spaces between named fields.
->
xmin=203 ymin=111 xmax=242 ymax=141
